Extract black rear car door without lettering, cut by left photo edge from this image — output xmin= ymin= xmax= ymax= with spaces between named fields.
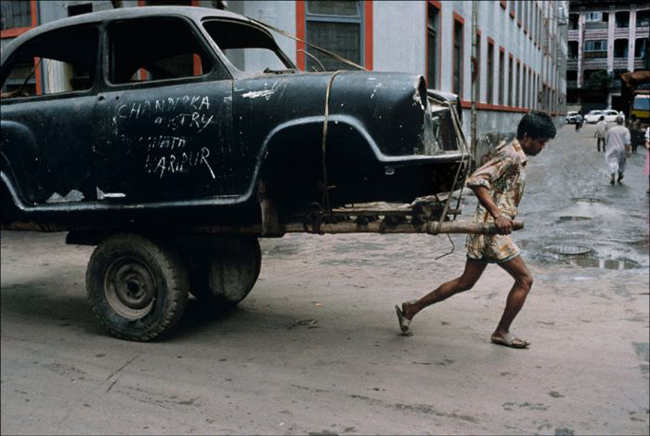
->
xmin=0 ymin=25 xmax=99 ymax=207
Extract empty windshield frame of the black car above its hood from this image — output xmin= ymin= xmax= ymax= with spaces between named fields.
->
xmin=201 ymin=16 xmax=299 ymax=75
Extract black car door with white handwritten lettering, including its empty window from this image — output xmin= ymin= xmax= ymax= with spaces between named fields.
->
xmin=95 ymin=17 xmax=237 ymax=203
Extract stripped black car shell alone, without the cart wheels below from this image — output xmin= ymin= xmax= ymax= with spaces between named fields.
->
xmin=1 ymin=7 xmax=463 ymax=230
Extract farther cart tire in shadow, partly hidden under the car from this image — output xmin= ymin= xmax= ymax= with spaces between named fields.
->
xmin=188 ymin=236 xmax=262 ymax=309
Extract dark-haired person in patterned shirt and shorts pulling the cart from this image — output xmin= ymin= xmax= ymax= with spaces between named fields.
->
xmin=395 ymin=112 xmax=556 ymax=348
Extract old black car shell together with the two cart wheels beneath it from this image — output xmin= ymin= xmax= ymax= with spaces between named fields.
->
xmin=0 ymin=7 xmax=468 ymax=340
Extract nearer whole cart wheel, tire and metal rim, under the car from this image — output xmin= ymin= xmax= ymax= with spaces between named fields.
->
xmin=86 ymin=234 xmax=189 ymax=341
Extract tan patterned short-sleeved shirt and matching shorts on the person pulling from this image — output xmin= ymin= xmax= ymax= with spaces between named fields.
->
xmin=465 ymin=139 xmax=528 ymax=263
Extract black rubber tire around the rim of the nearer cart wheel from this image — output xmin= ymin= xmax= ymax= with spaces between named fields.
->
xmin=86 ymin=234 xmax=189 ymax=341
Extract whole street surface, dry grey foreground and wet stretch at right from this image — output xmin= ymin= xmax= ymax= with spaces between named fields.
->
xmin=0 ymin=125 xmax=650 ymax=435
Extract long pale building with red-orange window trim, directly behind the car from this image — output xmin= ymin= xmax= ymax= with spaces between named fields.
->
xmin=0 ymin=0 xmax=568 ymax=158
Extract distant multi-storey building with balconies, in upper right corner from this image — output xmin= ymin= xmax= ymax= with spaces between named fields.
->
xmin=567 ymin=0 xmax=650 ymax=111
